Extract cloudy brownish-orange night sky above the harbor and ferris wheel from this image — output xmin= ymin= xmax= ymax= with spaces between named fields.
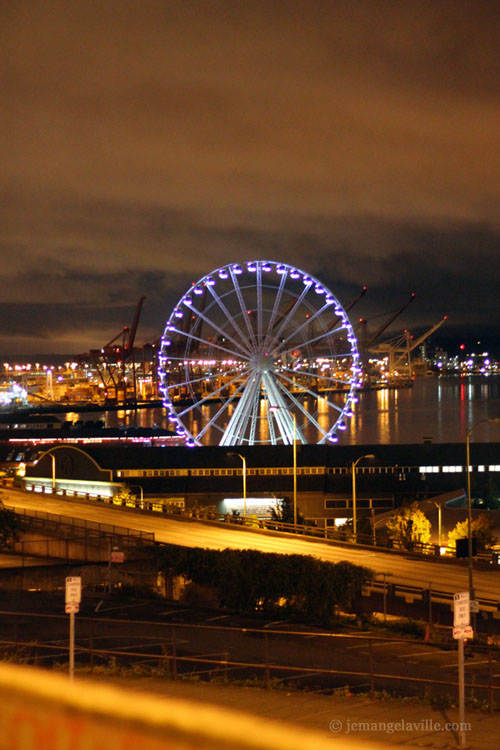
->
xmin=0 ymin=0 xmax=500 ymax=357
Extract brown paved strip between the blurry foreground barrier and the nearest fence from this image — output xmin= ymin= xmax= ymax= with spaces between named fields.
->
xmin=84 ymin=676 xmax=500 ymax=750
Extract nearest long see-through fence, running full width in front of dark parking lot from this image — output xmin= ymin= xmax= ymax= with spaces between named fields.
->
xmin=0 ymin=612 xmax=500 ymax=711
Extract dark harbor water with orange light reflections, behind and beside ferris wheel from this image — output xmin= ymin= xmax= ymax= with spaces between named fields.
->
xmin=66 ymin=377 xmax=500 ymax=445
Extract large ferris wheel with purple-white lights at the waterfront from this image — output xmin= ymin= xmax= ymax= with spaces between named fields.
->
xmin=158 ymin=260 xmax=361 ymax=446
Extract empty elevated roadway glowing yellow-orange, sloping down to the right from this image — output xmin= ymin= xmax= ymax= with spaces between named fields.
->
xmin=3 ymin=489 xmax=500 ymax=601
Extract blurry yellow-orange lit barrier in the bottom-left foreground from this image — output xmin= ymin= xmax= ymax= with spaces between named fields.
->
xmin=0 ymin=664 xmax=382 ymax=750
